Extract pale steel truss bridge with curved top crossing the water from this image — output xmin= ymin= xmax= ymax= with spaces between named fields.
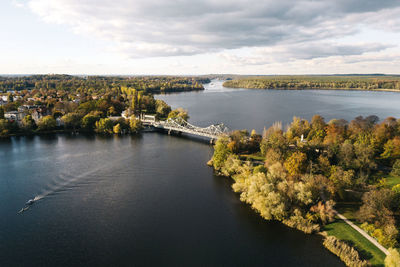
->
xmin=142 ymin=118 xmax=230 ymax=141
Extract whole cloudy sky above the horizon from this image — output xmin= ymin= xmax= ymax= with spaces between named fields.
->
xmin=0 ymin=0 xmax=400 ymax=75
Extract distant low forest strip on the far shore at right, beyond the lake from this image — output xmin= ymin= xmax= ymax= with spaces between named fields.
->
xmin=224 ymin=76 xmax=400 ymax=90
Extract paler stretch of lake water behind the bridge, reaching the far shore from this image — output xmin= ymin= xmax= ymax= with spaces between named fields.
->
xmin=157 ymin=80 xmax=400 ymax=132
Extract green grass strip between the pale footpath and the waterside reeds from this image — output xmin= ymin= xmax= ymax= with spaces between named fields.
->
xmin=324 ymin=220 xmax=385 ymax=266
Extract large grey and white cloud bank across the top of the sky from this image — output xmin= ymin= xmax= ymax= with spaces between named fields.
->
xmin=21 ymin=0 xmax=400 ymax=61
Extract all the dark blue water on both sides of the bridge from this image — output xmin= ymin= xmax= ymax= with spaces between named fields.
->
xmin=0 ymin=81 xmax=400 ymax=266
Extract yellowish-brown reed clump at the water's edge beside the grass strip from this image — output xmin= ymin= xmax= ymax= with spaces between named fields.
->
xmin=324 ymin=236 xmax=369 ymax=267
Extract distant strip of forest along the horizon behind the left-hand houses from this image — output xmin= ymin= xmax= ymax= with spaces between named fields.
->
xmin=0 ymin=75 xmax=210 ymax=95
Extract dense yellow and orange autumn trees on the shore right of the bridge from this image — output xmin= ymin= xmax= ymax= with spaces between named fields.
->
xmin=210 ymin=115 xmax=400 ymax=266
